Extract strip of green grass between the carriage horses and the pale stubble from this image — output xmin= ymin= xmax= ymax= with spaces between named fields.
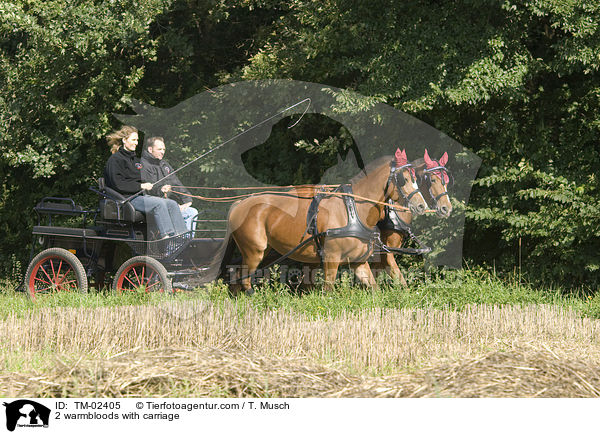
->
xmin=0 ymin=269 xmax=600 ymax=318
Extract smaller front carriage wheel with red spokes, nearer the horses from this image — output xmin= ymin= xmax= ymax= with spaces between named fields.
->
xmin=113 ymin=256 xmax=173 ymax=294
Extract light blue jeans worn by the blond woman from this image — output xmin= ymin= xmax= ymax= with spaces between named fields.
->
xmin=131 ymin=196 xmax=187 ymax=238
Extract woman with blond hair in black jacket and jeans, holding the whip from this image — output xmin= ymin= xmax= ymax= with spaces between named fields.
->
xmin=104 ymin=125 xmax=187 ymax=239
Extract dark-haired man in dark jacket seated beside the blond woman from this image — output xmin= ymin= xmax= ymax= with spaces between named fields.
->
xmin=142 ymin=137 xmax=198 ymax=231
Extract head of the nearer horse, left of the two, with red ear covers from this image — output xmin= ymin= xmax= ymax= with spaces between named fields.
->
xmin=386 ymin=148 xmax=427 ymax=215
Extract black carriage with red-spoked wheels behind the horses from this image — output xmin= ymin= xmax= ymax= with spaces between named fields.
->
xmin=24 ymin=179 xmax=226 ymax=298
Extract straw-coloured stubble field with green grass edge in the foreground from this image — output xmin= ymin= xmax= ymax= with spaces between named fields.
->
xmin=0 ymin=270 xmax=600 ymax=397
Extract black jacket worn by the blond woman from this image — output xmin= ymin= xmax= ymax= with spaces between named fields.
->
xmin=104 ymin=146 xmax=142 ymax=196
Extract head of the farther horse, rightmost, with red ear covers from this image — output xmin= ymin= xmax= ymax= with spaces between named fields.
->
xmin=418 ymin=149 xmax=452 ymax=218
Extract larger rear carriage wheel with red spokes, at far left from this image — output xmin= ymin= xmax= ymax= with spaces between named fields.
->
xmin=25 ymin=247 xmax=88 ymax=300
